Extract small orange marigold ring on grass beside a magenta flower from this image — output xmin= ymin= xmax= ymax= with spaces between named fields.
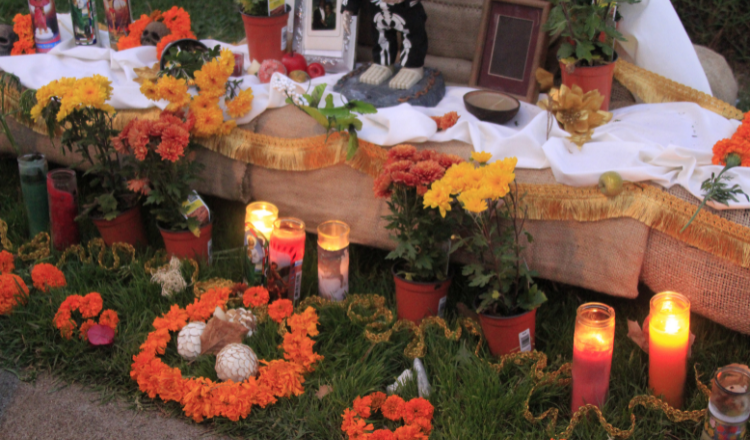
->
xmin=53 ymin=292 xmax=120 ymax=341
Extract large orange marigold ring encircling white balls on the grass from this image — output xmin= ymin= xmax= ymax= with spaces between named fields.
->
xmin=130 ymin=287 xmax=323 ymax=422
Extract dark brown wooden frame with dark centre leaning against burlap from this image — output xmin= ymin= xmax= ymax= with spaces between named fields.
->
xmin=469 ymin=0 xmax=550 ymax=103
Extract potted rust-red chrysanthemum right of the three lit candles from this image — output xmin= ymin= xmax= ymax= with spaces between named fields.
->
xmin=374 ymin=145 xmax=463 ymax=322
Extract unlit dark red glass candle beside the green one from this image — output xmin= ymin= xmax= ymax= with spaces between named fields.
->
xmin=47 ymin=169 xmax=81 ymax=251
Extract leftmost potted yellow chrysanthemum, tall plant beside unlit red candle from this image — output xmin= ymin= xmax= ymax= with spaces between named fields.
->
xmin=31 ymin=75 xmax=146 ymax=245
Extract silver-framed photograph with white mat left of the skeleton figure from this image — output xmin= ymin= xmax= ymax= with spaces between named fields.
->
xmin=292 ymin=0 xmax=357 ymax=73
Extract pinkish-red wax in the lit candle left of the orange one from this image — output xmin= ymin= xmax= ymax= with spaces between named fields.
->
xmin=572 ymin=334 xmax=613 ymax=412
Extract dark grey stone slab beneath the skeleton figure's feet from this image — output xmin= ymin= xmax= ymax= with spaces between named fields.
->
xmin=333 ymin=64 xmax=445 ymax=108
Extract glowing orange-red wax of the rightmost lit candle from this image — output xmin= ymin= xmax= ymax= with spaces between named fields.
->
xmin=648 ymin=315 xmax=690 ymax=408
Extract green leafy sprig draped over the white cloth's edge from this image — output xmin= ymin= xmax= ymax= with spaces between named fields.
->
xmin=286 ymin=84 xmax=378 ymax=160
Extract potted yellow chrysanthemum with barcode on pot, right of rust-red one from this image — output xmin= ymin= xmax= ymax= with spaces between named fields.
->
xmin=424 ymin=153 xmax=547 ymax=356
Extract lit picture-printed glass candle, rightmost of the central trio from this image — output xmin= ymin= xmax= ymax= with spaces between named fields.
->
xmin=318 ymin=220 xmax=349 ymax=301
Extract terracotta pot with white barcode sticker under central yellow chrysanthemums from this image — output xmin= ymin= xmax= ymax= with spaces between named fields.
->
xmin=479 ymin=309 xmax=536 ymax=356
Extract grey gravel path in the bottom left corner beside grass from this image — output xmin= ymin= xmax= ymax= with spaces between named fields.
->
xmin=0 ymin=370 xmax=226 ymax=440
